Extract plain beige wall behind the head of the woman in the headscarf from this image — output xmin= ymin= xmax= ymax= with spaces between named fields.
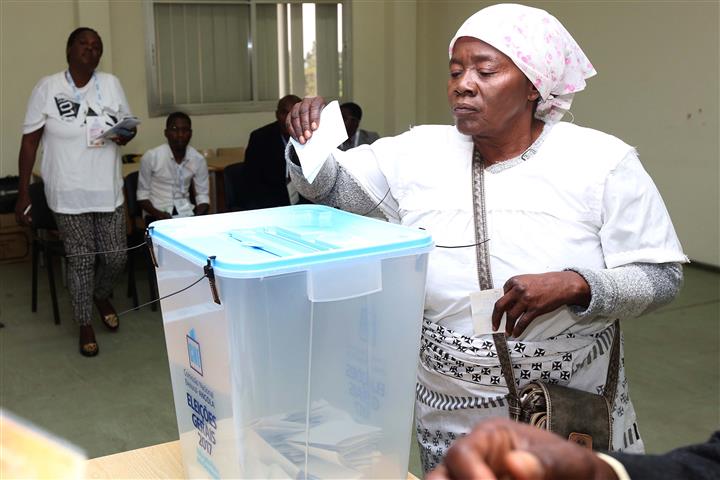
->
xmin=417 ymin=0 xmax=720 ymax=266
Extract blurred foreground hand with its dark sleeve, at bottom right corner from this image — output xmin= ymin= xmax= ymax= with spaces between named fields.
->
xmin=425 ymin=418 xmax=720 ymax=480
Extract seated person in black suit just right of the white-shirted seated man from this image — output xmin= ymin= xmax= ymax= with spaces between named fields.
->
xmin=241 ymin=95 xmax=300 ymax=209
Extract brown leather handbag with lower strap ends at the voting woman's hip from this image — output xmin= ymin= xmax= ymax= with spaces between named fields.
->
xmin=493 ymin=320 xmax=620 ymax=450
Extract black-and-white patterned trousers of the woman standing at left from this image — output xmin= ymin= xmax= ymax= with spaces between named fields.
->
xmin=53 ymin=206 xmax=127 ymax=325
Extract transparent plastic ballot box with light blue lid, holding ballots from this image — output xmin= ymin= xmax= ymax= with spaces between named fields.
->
xmin=150 ymin=205 xmax=433 ymax=479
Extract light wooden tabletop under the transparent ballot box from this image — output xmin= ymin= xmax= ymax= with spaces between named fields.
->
xmin=86 ymin=440 xmax=418 ymax=480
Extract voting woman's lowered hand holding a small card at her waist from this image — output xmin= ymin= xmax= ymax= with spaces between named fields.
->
xmin=492 ymin=271 xmax=590 ymax=337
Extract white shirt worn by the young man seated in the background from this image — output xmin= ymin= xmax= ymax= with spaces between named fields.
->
xmin=137 ymin=143 xmax=210 ymax=217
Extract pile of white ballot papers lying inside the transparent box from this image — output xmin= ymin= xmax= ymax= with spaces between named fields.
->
xmin=246 ymin=400 xmax=382 ymax=479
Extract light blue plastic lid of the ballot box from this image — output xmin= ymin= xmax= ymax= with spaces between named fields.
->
xmin=151 ymin=205 xmax=433 ymax=278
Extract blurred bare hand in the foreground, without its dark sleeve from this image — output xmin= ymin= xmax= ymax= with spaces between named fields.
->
xmin=425 ymin=418 xmax=617 ymax=480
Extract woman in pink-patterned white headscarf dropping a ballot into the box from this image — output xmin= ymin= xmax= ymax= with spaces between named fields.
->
xmin=287 ymin=4 xmax=687 ymax=471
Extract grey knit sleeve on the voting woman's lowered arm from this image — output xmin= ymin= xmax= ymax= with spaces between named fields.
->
xmin=566 ymin=263 xmax=683 ymax=319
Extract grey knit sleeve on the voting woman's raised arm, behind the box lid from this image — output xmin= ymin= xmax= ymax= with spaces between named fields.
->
xmin=285 ymin=143 xmax=387 ymax=220
